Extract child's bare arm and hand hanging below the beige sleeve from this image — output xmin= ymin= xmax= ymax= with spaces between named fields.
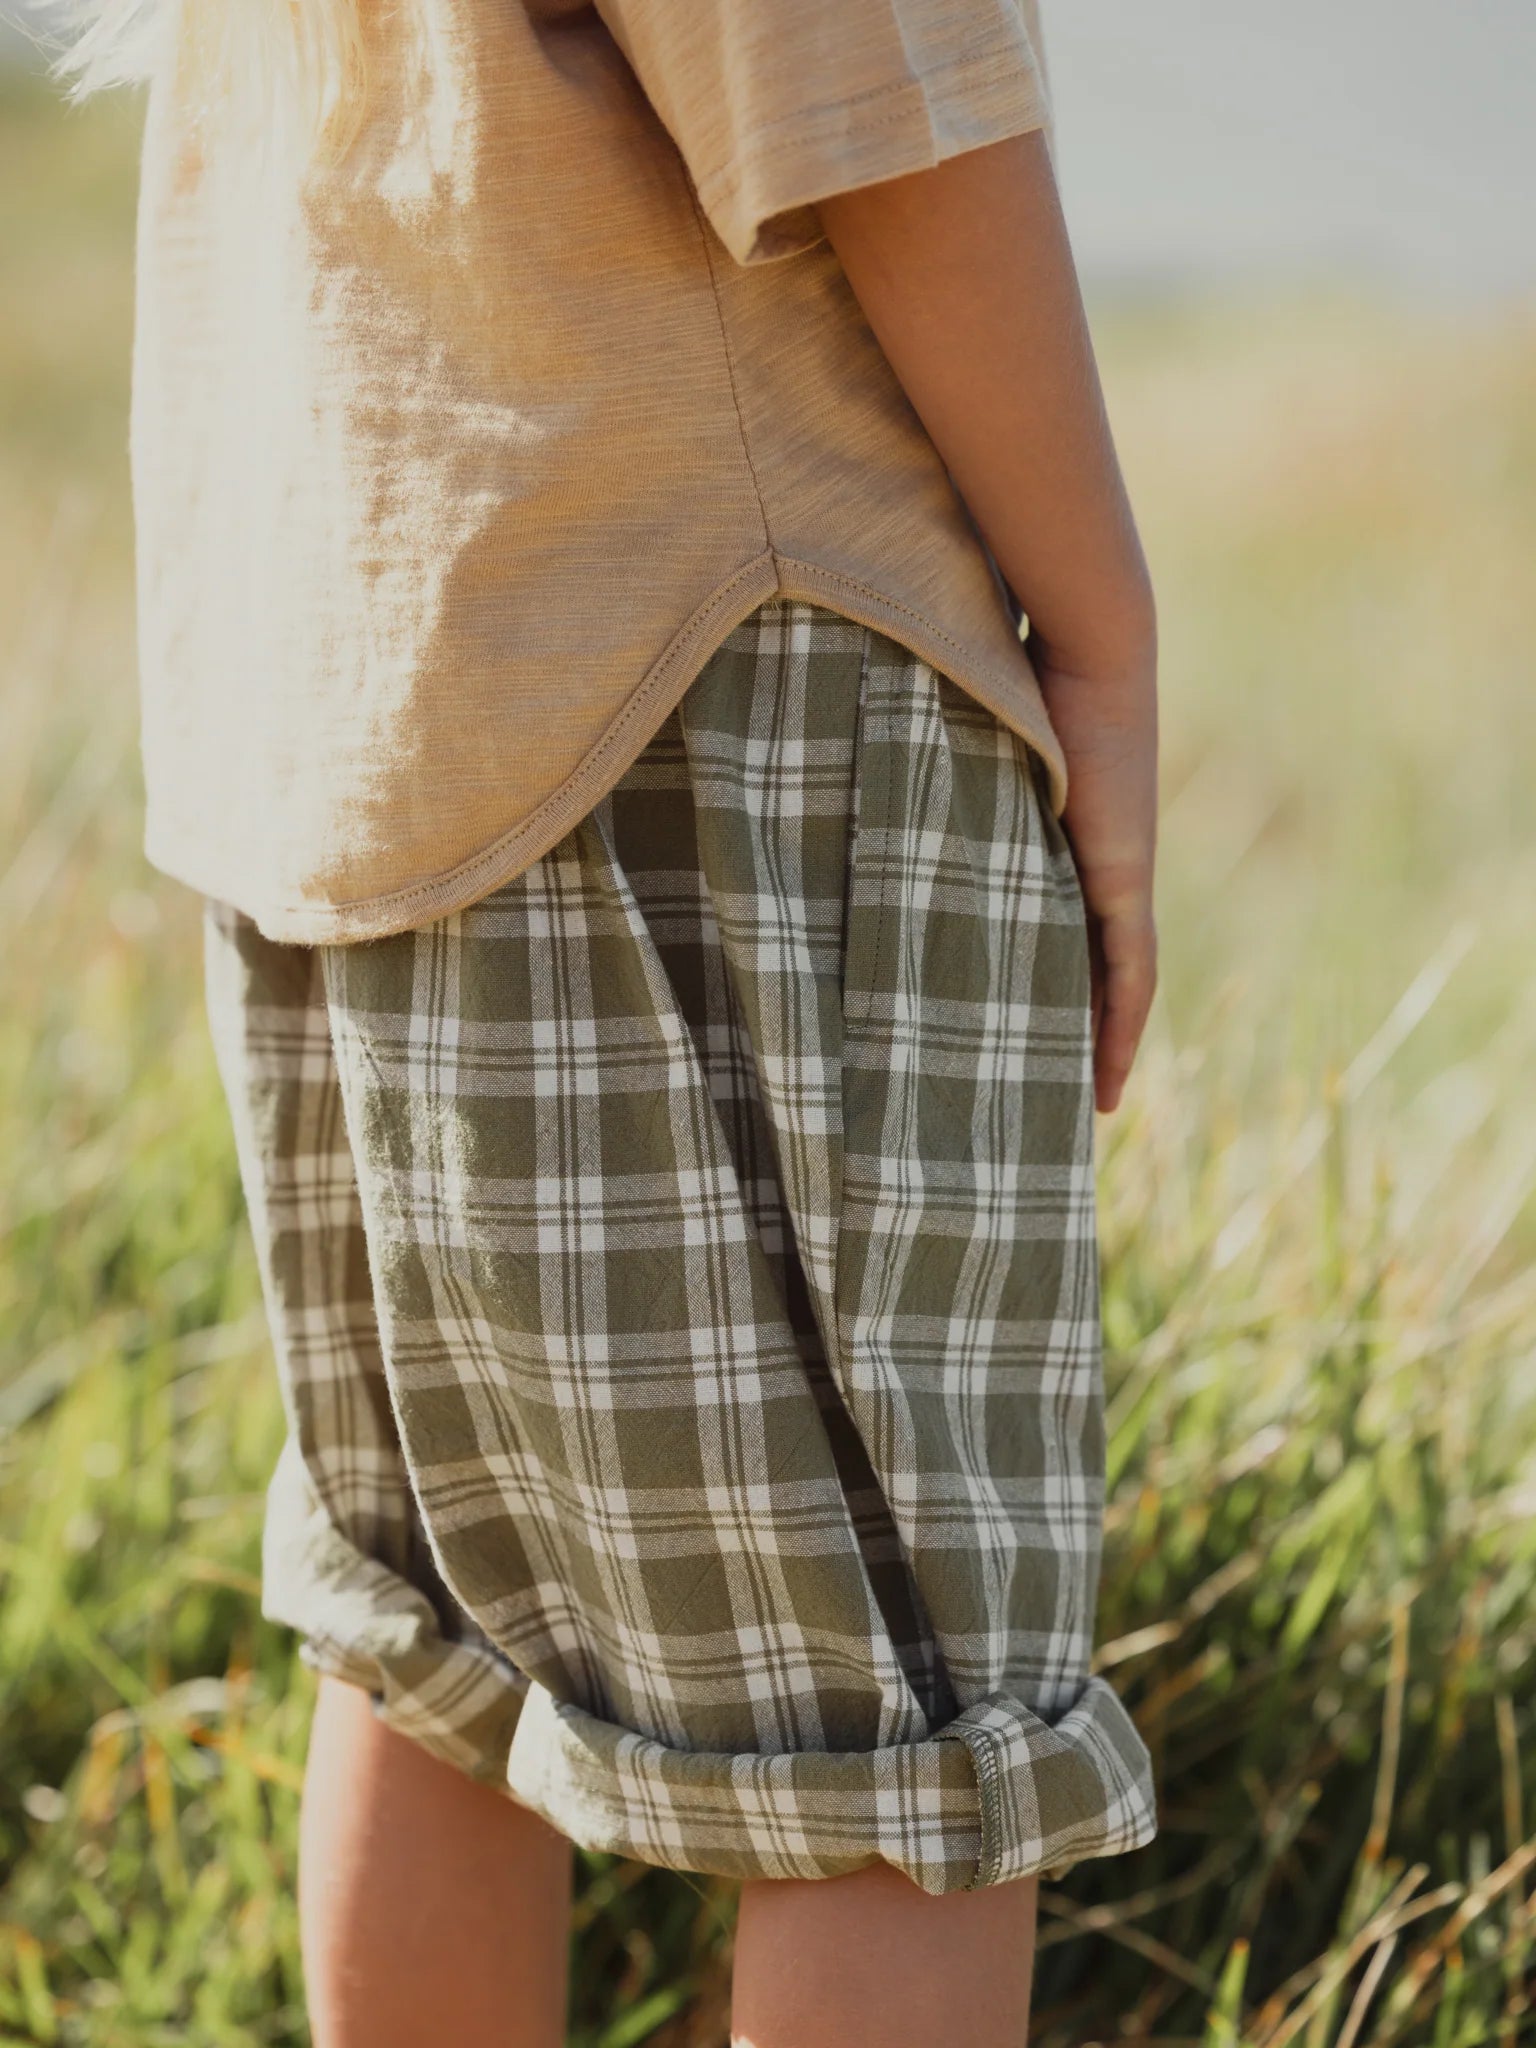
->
xmin=819 ymin=131 xmax=1157 ymax=1110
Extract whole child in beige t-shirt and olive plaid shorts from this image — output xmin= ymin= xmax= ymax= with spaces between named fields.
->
xmin=66 ymin=0 xmax=1155 ymax=2048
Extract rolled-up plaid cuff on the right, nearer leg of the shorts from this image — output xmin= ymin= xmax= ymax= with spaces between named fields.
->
xmin=506 ymin=1679 xmax=1157 ymax=1892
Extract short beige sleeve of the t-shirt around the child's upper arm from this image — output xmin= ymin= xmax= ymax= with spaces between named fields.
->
xmin=596 ymin=0 xmax=1049 ymax=264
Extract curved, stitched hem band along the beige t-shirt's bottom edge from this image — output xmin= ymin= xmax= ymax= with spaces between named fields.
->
xmin=153 ymin=549 xmax=1067 ymax=946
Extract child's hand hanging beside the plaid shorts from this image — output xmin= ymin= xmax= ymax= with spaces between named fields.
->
xmin=1030 ymin=637 xmax=1157 ymax=1112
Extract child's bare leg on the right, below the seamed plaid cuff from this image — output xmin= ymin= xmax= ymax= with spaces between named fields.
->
xmin=731 ymin=1864 xmax=1036 ymax=2048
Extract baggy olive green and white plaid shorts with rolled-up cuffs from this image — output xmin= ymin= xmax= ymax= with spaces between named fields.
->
xmin=207 ymin=602 xmax=1155 ymax=1892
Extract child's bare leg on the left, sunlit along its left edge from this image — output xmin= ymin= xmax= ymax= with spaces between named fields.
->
xmin=299 ymin=1679 xmax=571 ymax=2048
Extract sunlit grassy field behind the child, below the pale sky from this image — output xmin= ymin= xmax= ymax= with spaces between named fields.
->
xmin=0 ymin=44 xmax=1536 ymax=2048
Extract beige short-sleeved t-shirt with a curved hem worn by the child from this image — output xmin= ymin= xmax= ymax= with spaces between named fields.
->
xmin=131 ymin=0 xmax=1065 ymax=942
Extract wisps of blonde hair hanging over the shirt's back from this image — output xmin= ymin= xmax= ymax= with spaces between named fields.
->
xmin=53 ymin=0 xmax=367 ymax=154
